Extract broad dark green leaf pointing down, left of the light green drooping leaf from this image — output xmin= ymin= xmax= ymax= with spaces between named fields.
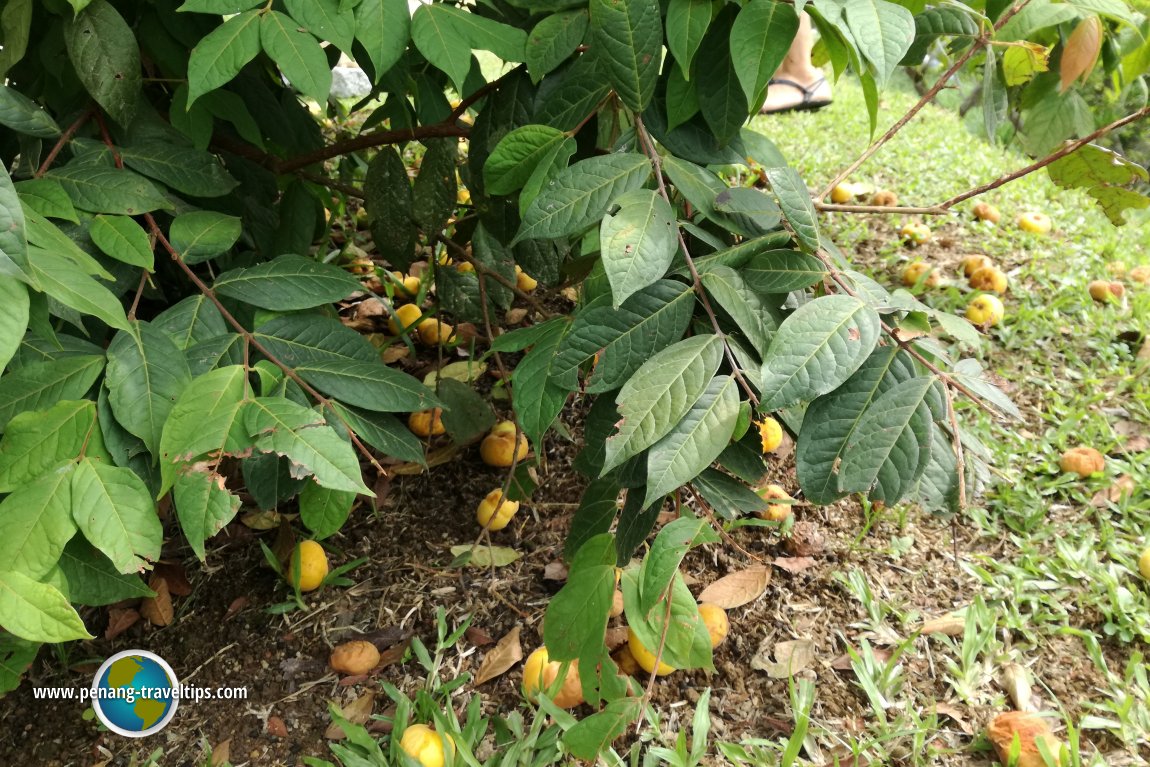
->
xmin=107 ymin=321 xmax=192 ymax=455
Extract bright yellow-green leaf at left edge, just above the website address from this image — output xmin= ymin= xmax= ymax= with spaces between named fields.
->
xmin=0 ymin=570 xmax=93 ymax=642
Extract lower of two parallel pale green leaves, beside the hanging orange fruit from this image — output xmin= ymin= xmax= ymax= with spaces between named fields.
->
xmin=643 ymin=376 xmax=738 ymax=510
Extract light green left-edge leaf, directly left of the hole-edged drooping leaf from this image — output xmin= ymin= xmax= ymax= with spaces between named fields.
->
xmin=0 ymin=464 xmax=75 ymax=578
